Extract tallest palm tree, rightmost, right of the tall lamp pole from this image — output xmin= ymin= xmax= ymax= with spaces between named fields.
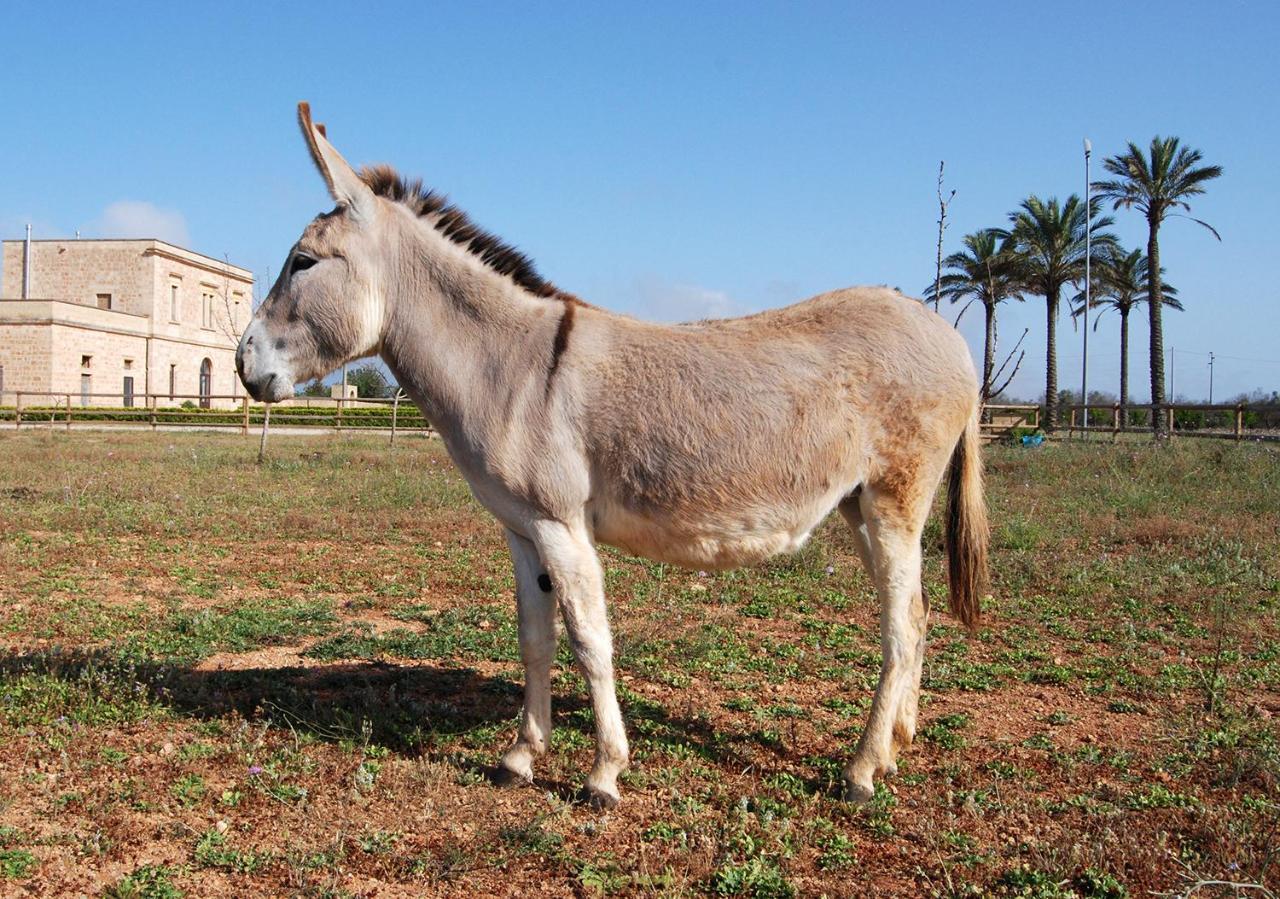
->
xmin=1093 ymin=136 xmax=1222 ymax=439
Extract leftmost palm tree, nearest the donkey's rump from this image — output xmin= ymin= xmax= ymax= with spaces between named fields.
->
xmin=924 ymin=228 xmax=1021 ymax=405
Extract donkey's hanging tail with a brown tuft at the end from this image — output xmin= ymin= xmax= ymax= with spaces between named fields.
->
xmin=946 ymin=410 xmax=987 ymax=630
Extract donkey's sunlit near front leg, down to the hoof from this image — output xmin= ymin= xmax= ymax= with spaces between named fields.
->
xmin=534 ymin=521 xmax=627 ymax=808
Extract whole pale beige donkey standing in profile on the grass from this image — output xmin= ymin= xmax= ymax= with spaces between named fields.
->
xmin=236 ymin=102 xmax=987 ymax=808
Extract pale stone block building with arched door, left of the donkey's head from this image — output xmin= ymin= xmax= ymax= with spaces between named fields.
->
xmin=0 ymin=239 xmax=253 ymax=407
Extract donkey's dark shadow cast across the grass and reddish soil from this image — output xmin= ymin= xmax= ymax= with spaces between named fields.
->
xmin=0 ymin=649 xmax=757 ymax=799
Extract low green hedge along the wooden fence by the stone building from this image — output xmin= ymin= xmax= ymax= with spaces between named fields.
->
xmin=0 ymin=403 xmax=428 ymax=429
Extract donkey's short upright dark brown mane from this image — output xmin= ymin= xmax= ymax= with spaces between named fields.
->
xmin=360 ymin=165 xmax=581 ymax=302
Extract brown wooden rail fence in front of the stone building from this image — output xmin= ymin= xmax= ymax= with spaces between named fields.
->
xmin=0 ymin=391 xmax=431 ymax=443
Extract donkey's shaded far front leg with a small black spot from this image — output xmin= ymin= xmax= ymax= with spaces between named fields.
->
xmin=498 ymin=530 xmax=556 ymax=785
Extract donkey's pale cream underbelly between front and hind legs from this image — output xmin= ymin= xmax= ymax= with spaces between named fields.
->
xmin=591 ymin=494 xmax=840 ymax=569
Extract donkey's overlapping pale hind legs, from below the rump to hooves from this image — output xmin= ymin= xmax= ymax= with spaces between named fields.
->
xmin=841 ymin=488 xmax=932 ymax=802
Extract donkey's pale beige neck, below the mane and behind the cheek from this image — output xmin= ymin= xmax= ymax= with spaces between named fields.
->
xmin=381 ymin=225 xmax=564 ymax=455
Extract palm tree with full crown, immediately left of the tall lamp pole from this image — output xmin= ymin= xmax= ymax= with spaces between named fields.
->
xmin=1000 ymin=193 xmax=1115 ymax=430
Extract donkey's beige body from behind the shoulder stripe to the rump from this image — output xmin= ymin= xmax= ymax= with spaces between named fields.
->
xmin=580 ymin=288 xmax=977 ymax=567
